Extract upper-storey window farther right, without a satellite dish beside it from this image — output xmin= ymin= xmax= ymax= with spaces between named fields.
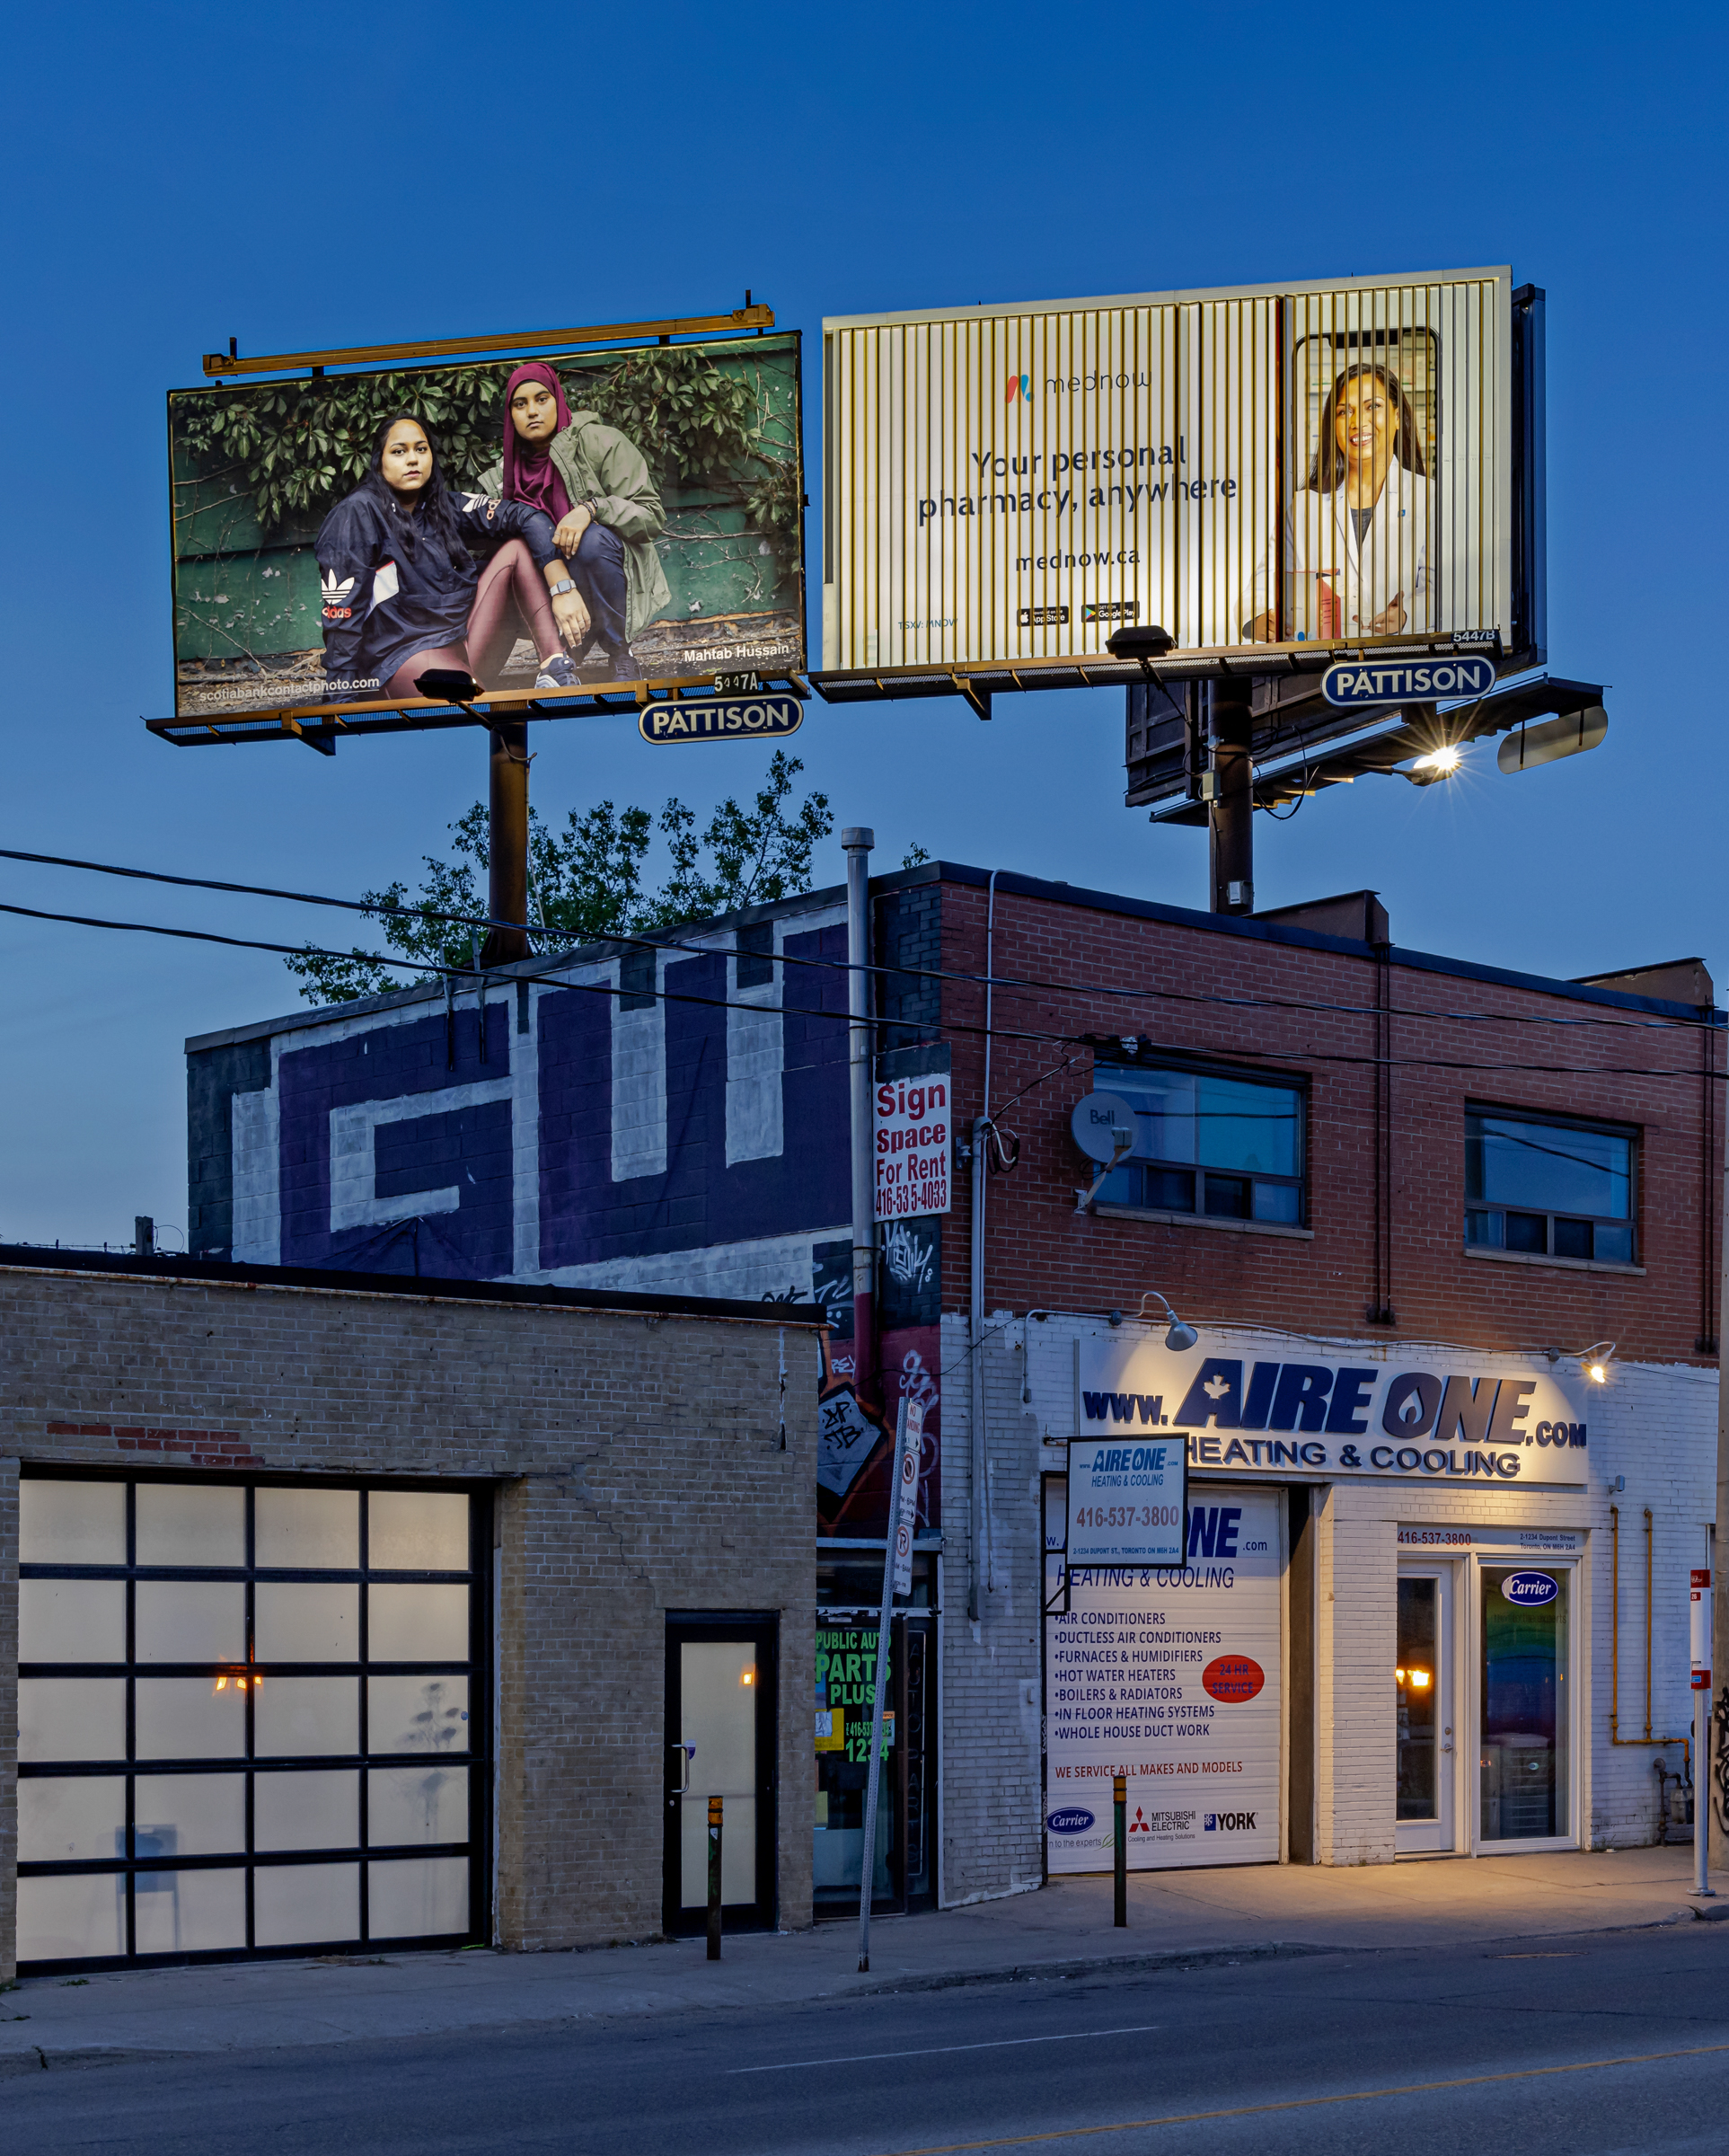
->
xmin=1464 ymin=1109 xmax=1636 ymax=1266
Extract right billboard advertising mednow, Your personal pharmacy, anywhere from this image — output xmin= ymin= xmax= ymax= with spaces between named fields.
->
xmin=824 ymin=270 xmax=1531 ymax=670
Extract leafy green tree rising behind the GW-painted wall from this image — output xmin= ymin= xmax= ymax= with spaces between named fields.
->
xmin=287 ymin=748 xmax=834 ymax=1003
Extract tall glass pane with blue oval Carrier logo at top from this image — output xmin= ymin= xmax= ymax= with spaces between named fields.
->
xmin=1479 ymin=1565 xmax=1569 ymax=1842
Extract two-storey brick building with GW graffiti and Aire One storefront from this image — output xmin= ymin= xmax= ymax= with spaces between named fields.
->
xmin=188 ymin=862 xmax=1723 ymax=1908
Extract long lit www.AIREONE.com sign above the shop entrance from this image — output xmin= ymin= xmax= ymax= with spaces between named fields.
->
xmin=1073 ymin=1332 xmax=1589 ymax=1486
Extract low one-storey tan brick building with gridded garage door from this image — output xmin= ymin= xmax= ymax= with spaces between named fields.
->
xmin=0 ymin=1249 xmax=819 ymax=1979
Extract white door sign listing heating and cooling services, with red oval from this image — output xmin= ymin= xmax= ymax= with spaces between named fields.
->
xmin=1045 ymin=1488 xmax=1283 ymax=1876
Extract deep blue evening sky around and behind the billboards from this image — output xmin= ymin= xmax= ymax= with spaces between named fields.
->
xmin=0 ymin=0 xmax=1729 ymax=1241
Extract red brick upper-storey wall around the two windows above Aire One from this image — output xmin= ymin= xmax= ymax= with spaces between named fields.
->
xmin=942 ymin=884 xmax=1725 ymax=1360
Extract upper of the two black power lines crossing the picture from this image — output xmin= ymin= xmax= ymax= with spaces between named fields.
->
xmin=0 ymin=847 xmax=1720 ymax=1038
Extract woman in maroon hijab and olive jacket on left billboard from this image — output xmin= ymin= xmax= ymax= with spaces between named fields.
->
xmin=481 ymin=360 xmax=673 ymax=681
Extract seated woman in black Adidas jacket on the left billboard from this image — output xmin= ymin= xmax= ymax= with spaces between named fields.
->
xmin=314 ymin=411 xmax=588 ymax=701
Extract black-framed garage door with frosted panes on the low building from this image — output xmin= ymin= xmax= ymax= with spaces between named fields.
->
xmin=17 ymin=1472 xmax=490 ymax=1973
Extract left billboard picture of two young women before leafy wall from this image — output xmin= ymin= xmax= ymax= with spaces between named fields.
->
xmin=168 ymin=332 xmax=804 ymax=718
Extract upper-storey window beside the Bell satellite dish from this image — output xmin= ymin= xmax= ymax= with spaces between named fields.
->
xmin=1093 ymin=1063 xmax=1307 ymax=1227
